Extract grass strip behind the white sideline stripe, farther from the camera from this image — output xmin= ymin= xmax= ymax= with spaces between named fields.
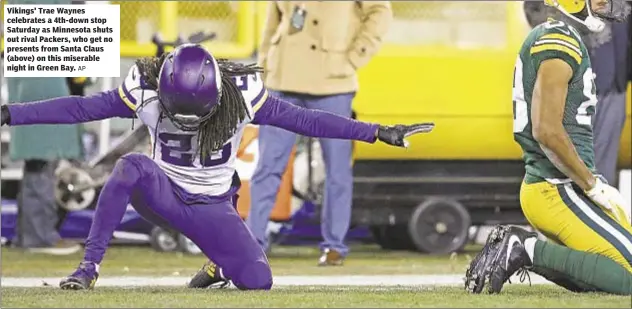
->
xmin=2 ymin=246 xmax=475 ymax=277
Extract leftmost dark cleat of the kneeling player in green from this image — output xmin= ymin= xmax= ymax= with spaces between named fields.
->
xmin=465 ymin=228 xmax=500 ymax=294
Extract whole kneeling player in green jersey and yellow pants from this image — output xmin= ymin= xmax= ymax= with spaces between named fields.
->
xmin=466 ymin=0 xmax=632 ymax=295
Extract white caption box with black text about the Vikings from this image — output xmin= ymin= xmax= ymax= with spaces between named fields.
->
xmin=3 ymin=3 xmax=121 ymax=77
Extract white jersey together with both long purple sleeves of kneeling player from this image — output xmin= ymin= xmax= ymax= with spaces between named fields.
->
xmin=7 ymin=66 xmax=378 ymax=195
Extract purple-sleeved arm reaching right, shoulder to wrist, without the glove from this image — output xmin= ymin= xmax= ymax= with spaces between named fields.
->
xmin=253 ymin=96 xmax=379 ymax=143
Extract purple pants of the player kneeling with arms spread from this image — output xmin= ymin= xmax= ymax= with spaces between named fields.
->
xmin=85 ymin=154 xmax=272 ymax=289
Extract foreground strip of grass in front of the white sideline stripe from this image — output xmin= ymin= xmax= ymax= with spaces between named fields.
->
xmin=2 ymin=286 xmax=631 ymax=308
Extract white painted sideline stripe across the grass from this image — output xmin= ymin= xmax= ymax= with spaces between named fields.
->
xmin=0 ymin=274 xmax=550 ymax=287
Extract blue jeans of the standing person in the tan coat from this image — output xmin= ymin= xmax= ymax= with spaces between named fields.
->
xmin=246 ymin=91 xmax=355 ymax=255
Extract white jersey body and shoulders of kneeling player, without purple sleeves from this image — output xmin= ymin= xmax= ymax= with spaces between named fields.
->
xmin=118 ymin=66 xmax=268 ymax=195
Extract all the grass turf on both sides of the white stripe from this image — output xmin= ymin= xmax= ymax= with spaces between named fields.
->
xmin=0 ymin=246 xmax=632 ymax=308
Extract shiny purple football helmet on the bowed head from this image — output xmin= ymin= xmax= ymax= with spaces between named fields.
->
xmin=158 ymin=44 xmax=222 ymax=131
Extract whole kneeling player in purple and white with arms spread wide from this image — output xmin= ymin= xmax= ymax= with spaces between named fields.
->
xmin=1 ymin=44 xmax=434 ymax=290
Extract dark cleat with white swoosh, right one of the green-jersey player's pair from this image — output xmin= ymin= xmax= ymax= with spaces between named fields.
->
xmin=486 ymin=226 xmax=538 ymax=293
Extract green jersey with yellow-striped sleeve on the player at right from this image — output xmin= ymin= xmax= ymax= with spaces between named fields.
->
xmin=513 ymin=20 xmax=597 ymax=183
